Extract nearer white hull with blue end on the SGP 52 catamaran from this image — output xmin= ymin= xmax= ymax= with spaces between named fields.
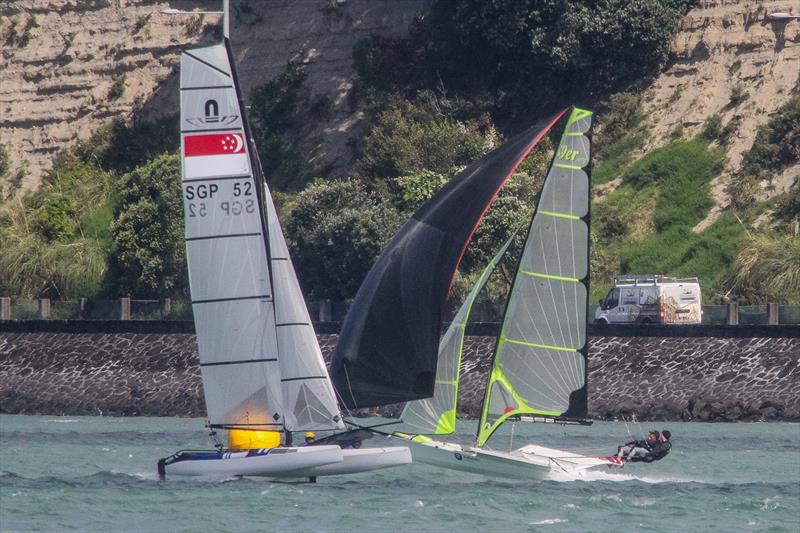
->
xmin=159 ymin=446 xmax=343 ymax=477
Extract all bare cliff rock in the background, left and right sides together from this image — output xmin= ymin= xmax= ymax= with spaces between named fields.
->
xmin=0 ymin=0 xmax=800 ymax=204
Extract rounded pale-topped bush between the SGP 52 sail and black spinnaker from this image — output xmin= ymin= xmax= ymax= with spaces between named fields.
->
xmin=286 ymin=180 xmax=401 ymax=300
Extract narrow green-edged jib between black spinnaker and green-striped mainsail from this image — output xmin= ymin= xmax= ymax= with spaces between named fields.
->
xmin=400 ymin=232 xmax=516 ymax=435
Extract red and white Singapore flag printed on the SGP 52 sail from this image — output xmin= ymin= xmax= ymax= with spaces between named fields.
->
xmin=183 ymin=131 xmax=250 ymax=179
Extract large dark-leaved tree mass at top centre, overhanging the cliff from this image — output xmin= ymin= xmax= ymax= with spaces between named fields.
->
xmin=354 ymin=0 xmax=696 ymax=117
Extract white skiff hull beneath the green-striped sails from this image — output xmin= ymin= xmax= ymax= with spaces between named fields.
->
xmin=410 ymin=440 xmax=619 ymax=480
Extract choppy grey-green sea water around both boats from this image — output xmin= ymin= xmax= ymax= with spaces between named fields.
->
xmin=0 ymin=415 xmax=800 ymax=533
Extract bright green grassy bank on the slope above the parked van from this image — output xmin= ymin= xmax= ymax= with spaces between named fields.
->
xmin=591 ymin=138 xmax=744 ymax=302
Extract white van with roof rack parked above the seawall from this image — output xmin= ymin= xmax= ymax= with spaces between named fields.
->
xmin=594 ymin=276 xmax=703 ymax=324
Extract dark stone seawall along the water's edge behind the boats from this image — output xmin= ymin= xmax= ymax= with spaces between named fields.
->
xmin=0 ymin=322 xmax=800 ymax=421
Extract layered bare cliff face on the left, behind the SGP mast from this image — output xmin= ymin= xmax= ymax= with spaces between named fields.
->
xmin=0 ymin=0 xmax=429 ymax=189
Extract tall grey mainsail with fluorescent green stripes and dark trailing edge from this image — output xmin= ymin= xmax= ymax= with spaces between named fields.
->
xmin=478 ymin=108 xmax=592 ymax=446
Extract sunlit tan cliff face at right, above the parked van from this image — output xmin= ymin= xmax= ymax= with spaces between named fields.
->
xmin=643 ymin=0 xmax=800 ymax=230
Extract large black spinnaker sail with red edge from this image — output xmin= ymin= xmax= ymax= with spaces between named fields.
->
xmin=331 ymin=109 xmax=567 ymax=409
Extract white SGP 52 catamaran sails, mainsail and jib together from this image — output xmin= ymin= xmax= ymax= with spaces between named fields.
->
xmin=181 ymin=44 xmax=343 ymax=431
